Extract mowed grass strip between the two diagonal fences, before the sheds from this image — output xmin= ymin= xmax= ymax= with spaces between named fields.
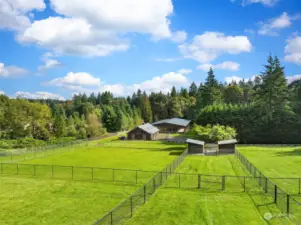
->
xmin=125 ymin=155 xmax=294 ymax=225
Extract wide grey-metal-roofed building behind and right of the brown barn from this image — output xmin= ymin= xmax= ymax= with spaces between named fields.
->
xmin=153 ymin=118 xmax=190 ymax=133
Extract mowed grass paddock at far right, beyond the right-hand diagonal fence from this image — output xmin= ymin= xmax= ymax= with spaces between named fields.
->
xmin=238 ymin=146 xmax=301 ymax=195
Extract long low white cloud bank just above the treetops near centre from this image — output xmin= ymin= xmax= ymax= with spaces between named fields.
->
xmin=44 ymin=69 xmax=191 ymax=96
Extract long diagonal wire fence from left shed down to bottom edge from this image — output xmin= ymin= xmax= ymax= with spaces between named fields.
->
xmin=94 ymin=150 xmax=188 ymax=225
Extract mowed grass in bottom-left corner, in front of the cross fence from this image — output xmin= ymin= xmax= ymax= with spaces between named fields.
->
xmin=0 ymin=177 xmax=137 ymax=225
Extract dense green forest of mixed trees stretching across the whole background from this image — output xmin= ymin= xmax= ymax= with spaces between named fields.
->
xmin=0 ymin=55 xmax=301 ymax=147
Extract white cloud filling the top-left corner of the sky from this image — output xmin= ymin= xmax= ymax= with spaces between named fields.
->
xmin=0 ymin=0 xmax=46 ymax=31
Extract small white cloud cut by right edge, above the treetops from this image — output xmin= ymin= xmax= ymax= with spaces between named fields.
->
xmin=284 ymin=36 xmax=301 ymax=65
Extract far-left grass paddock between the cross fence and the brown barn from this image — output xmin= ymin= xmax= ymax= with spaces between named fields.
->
xmin=19 ymin=141 xmax=186 ymax=171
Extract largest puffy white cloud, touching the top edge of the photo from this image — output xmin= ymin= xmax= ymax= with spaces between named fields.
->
xmin=17 ymin=0 xmax=183 ymax=56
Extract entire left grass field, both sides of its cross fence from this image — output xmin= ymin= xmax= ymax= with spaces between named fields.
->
xmin=0 ymin=141 xmax=185 ymax=225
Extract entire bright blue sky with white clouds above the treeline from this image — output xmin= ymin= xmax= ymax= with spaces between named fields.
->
xmin=0 ymin=0 xmax=301 ymax=99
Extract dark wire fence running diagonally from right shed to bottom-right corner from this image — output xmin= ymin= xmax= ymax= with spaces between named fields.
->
xmin=235 ymin=151 xmax=301 ymax=222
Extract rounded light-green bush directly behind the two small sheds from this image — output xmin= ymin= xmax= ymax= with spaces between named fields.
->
xmin=187 ymin=125 xmax=236 ymax=142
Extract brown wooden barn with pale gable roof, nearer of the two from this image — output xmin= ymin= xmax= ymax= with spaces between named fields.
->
xmin=127 ymin=123 xmax=159 ymax=140
